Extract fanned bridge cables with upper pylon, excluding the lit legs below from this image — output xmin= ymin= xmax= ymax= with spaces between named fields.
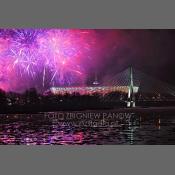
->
xmin=105 ymin=67 xmax=175 ymax=96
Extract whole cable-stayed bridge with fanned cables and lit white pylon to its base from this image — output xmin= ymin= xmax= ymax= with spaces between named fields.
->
xmin=105 ymin=67 xmax=175 ymax=107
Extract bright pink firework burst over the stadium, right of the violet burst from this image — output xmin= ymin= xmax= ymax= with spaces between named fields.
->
xmin=37 ymin=29 xmax=95 ymax=86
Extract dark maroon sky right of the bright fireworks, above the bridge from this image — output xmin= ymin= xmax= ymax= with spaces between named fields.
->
xmin=93 ymin=30 xmax=175 ymax=85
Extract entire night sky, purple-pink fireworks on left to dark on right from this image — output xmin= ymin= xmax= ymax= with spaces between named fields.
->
xmin=0 ymin=29 xmax=175 ymax=91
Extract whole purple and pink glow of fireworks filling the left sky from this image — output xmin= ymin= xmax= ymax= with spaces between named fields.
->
xmin=0 ymin=29 xmax=96 ymax=91
